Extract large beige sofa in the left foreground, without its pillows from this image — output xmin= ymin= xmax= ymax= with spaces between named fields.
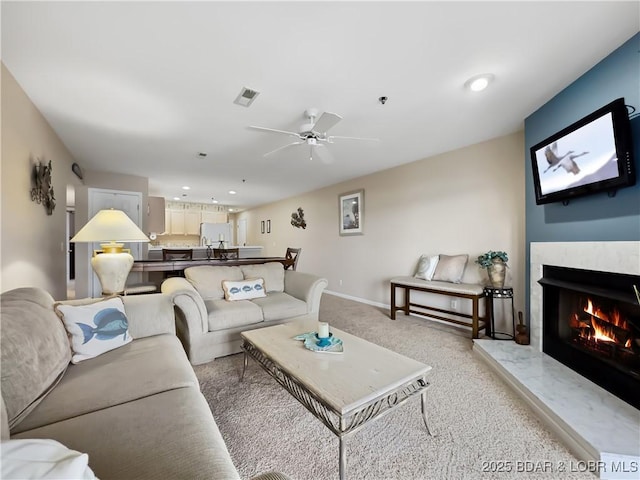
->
xmin=1 ymin=288 xmax=288 ymax=480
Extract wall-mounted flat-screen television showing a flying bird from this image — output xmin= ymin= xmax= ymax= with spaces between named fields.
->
xmin=531 ymin=98 xmax=636 ymax=205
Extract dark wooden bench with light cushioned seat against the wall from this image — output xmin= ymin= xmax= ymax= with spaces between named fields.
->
xmin=391 ymin=276 xmax=491 ymax=338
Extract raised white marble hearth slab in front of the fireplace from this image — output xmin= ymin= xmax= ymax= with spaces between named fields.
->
xmin=473 ymin=339 xmax=640 ymax=478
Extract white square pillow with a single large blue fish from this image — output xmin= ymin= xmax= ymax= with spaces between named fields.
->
xmin=56 ymin=297 xmax=132 ymax=363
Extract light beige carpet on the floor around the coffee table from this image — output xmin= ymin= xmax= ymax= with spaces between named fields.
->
xmin=195 ymin=294 xmax=595 ymax=480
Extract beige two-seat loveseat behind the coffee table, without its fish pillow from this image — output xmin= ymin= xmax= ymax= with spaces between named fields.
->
xmin=162 ymin=262 xmax=327 ymax=365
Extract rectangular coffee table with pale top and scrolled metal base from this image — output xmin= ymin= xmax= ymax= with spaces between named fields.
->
xmin=241 ymin=322 xmax=432 ymax=480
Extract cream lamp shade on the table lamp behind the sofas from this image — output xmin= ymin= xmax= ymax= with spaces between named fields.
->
xmin=70 ymin=210 xmax=149 ymax=243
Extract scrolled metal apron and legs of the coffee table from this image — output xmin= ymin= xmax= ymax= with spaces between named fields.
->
xmin=240 ymin=340 xmax=433 ymax=480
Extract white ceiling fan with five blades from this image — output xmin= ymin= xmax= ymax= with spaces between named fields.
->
xmin=249 ymin=108 xmax=379 ymax=163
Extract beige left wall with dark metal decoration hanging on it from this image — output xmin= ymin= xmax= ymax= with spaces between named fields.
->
xmin=0 ymin=64 xmax=80 ymax=299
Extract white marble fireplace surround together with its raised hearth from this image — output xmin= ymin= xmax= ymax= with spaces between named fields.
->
xmin=473 ymin=242 xmax=640 ymax=478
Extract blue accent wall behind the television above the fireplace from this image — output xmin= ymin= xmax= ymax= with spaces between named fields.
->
xmin=524 ymin=33 xmax=640 ymax=318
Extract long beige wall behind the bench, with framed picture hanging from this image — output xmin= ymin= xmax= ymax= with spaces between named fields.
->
xmin=237 ymin=132 xmax=525 ymax=316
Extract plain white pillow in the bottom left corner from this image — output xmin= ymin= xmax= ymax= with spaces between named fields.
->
xmin=0 ymin=438 xmax=97 ymax=480
